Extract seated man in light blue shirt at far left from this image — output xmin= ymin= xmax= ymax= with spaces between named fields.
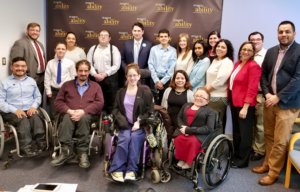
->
xmin=0 ymin=57 xmax=47 ymax=157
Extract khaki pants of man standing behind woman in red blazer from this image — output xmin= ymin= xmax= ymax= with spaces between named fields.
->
xmin=252 ymin=94 xmax=265 ymax=155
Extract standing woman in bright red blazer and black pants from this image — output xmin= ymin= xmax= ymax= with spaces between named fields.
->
xmin=228 ymin=41 xmax=261 ymax=168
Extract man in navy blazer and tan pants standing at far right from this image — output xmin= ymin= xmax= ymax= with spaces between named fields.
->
xmin=252 ymin=21 xmax=300 ymax=185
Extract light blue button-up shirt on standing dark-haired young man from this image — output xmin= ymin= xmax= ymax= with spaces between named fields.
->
xmin=148 ymin=44 xmax=176 ymax=84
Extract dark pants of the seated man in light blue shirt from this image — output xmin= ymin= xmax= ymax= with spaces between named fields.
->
xmin=1 ymin=112 xmax=45 ymax=148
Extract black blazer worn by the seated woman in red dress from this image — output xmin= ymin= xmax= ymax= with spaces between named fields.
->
xmin=175 ymin=103 xmax=217 ymax=142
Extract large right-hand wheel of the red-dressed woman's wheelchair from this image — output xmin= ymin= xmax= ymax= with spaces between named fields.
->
xmin=202 ymin=135 xmax=232 ymax=188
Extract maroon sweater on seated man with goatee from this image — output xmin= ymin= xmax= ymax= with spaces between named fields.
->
xmin=55 ymin=80 xmax=104 ymax=115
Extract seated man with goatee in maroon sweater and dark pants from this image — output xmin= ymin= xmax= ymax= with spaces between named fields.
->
xmin=51 ymin=60 xmax=104 ymax=168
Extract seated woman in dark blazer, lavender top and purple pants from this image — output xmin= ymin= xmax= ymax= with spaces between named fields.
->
xmin=109 ymin=64 xmax=153 ymax=182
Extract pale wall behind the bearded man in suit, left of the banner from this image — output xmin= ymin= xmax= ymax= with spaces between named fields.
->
xmin=0 ymin=0 xmax=46 ymax=80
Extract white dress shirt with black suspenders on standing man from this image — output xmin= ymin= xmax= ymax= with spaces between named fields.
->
xmin=87 ymin=44 xmax=121 ymax=76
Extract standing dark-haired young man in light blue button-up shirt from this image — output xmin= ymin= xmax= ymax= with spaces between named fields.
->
xmin=148 ymin=29 xmax=176 ymax=105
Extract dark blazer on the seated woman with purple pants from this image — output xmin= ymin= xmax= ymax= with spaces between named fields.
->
xmin=112 ymin=85 xmax=153 ymax=129
